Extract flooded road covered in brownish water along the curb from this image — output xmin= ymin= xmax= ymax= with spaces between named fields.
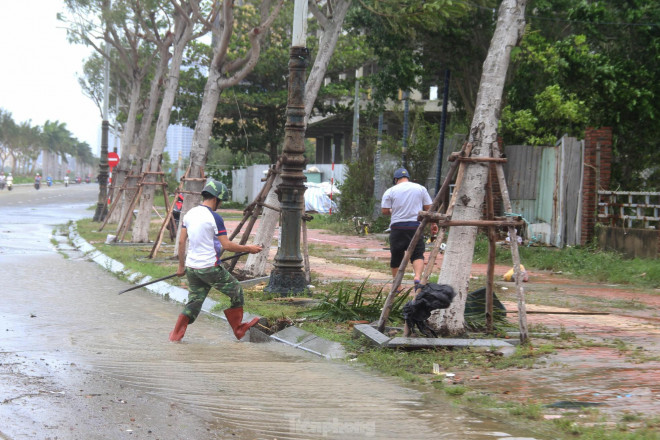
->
xmin=0 ymin=184 xmax=541 ymax=440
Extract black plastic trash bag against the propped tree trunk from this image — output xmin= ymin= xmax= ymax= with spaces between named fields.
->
xmin=403 ymin=283 xmax=456 ymax=338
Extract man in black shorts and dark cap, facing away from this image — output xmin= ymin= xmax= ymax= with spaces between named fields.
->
xmin=380 ymin=168 xmax=438 ymax=292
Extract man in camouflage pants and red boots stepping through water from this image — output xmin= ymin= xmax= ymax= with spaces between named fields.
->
xmin=170 ymin=180 xmax=262 ymax=341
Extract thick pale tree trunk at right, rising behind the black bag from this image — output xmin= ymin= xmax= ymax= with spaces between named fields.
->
xmin=430 ymin=0 xmax=526 ymax=335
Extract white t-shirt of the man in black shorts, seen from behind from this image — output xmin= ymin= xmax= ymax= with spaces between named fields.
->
xmin=380 ymin=182 xmax=433 ymax=226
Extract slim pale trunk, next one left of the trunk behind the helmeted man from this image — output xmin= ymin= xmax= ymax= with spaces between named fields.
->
xmin=127 ymin=9 xmax=193 ymax=243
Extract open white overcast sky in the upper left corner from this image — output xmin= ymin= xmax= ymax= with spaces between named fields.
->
xmin=0 ymin=0 xmax=102 ymax=156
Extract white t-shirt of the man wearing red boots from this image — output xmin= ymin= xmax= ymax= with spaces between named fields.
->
xmin=181 ymin=205 xmax=227 ymax=269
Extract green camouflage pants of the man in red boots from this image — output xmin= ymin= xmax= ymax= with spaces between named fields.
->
xmin=182 ymin=266 xmax=243 ymax=324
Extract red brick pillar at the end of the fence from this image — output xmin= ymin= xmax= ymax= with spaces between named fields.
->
xmin=580 ymin=127 xmax=612 ymax=245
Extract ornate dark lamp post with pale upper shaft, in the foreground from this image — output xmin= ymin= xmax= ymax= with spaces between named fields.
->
xmin=264 ymin=0 xmax=309 ymax=296
